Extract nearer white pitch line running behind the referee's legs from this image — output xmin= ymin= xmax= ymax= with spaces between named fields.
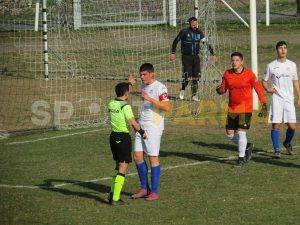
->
xmin=0 ymin=156 xmax=236 ymax=189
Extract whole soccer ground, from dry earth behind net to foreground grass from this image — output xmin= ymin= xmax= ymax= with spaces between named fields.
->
xmin=0 ymin=0 xmax=300 ymax=225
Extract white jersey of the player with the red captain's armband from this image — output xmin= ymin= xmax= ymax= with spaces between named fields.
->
xmin=139 ymin=80 xmax=169 ymax=131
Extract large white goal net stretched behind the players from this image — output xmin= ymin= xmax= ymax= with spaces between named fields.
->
xmin=0 ymin=0 xmax=270 ymax=134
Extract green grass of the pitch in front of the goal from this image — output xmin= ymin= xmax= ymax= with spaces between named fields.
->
xmin=0 ymin=123 xmax=300 ymax=225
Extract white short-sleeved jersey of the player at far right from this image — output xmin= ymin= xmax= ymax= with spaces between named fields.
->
xmin=263 ymin=59 xmax=298 ymax=103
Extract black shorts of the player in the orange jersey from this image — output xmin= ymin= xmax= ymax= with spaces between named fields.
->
xmin=226 ymin=113 xmax=252 ymax=130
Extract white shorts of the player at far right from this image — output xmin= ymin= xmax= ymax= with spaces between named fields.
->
xmin=269 ymin=97 xmax=297 ymax=123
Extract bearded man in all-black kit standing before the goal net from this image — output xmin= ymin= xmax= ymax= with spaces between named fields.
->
xmin=170 ymin=17 xmax=214 ymax=101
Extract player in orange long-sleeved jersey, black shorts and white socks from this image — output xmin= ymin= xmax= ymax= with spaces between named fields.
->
xmin=216 ymin=52 xmax=267 ymax=166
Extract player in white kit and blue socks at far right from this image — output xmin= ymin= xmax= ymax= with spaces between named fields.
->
xmin=262 ymin=41 xmax=300 ymax=158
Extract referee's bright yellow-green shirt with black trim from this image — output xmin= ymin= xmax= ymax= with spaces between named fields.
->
xmin=108 ymin=99 xmax=134 ymax=133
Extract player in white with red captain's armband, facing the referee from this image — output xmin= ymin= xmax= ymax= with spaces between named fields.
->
xmin=129 ymin=63 xmax=171 ymax=200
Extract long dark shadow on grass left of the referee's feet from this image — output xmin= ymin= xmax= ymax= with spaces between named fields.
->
xmin=37 ymin=179 xmax=131 ymax=204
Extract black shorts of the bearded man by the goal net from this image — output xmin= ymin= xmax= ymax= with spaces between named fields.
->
xmin=181 ymin=55 xmax=200 ymax=79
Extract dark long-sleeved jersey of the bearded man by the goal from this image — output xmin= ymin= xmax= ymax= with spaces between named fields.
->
xmin=172 ymin=28 xmax=205 ymax=55
